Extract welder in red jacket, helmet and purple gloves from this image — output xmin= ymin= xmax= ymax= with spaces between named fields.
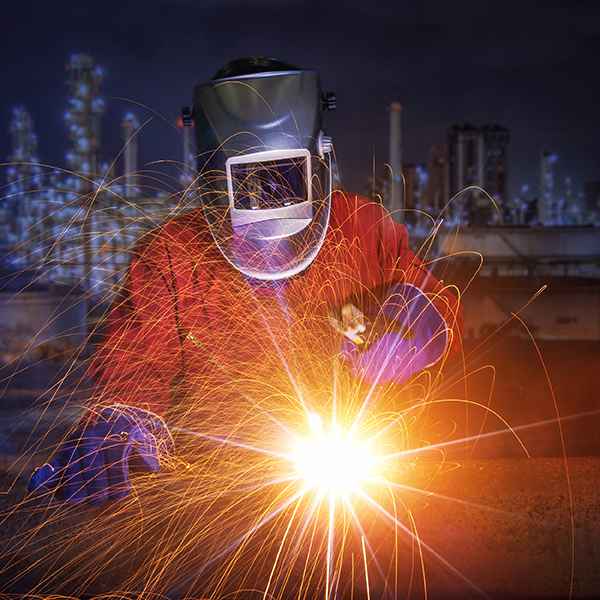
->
xmin=30 ymin=57 xmax=464 ymax=504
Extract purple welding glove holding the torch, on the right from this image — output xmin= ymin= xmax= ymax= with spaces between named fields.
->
xmin=340 ymin=284 xmax=448 ymax=383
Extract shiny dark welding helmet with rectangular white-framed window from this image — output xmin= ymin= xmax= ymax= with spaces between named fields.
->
xmin=190 ymin=57 xmax=335 ymax=280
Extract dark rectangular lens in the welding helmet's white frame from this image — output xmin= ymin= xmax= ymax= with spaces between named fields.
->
xmin=231 ymin=158 xmax=308 ymax=210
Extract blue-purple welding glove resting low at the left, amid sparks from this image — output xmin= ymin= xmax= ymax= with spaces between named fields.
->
xmin=29 ymin=404 xmax=175 ymax=505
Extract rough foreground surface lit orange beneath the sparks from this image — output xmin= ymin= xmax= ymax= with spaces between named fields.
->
xmin=0 ymin=457 xmax=600 ymax=599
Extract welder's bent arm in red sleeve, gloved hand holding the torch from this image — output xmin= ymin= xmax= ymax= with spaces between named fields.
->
xmin=330 ymin=195 xmax=464 ymax=383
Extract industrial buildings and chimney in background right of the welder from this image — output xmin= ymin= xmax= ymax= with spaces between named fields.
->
xmin=365 ymin=102 xmax=600 ymax=340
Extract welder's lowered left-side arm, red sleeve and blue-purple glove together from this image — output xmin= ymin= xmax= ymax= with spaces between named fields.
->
xmin=29 ymin=223 xmax=191 ymax=504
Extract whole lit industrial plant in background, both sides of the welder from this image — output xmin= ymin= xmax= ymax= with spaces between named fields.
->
xmin=0 ymin=54 xmax=600 ymax=362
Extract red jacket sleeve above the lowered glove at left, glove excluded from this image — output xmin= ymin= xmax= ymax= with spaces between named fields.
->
xmin=88 ymin=230 xmax=182 ymax=416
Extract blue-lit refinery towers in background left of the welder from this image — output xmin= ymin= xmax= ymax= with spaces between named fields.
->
xmin=0 ymin=54 xmax=192 ymax=296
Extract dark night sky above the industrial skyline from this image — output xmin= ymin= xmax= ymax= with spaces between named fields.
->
xmin=0 ymin=0 xmax=600 ymax=202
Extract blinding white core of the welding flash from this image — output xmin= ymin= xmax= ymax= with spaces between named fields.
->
xmin=294 ymin=413 xmax=373 ymax=494
